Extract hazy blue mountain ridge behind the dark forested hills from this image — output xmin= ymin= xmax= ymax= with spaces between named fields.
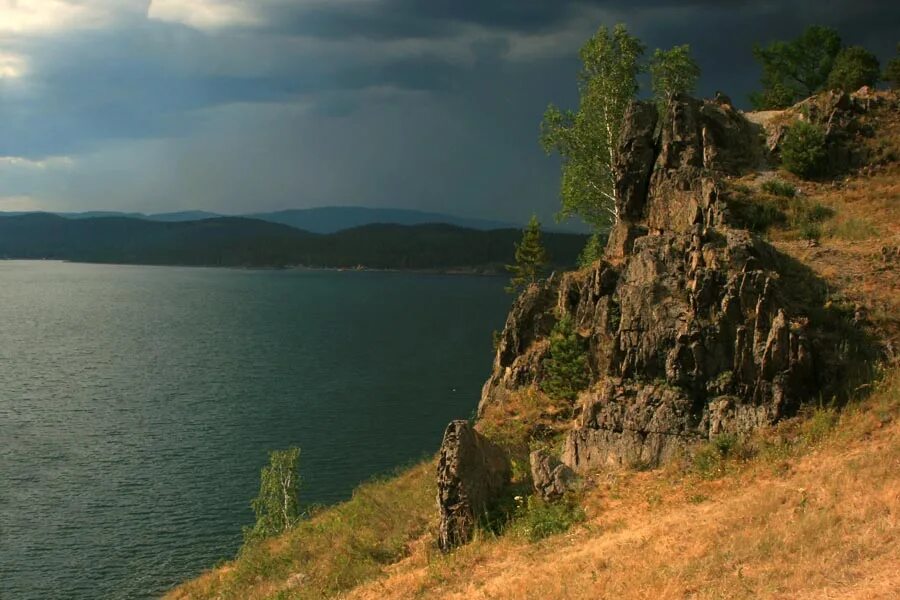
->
xmin=0 ymin=206 xmax=521 ymax=233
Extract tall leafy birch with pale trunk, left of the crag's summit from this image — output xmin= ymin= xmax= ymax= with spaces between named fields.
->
xmin=541 ymin=24 xmax=645 ymax=231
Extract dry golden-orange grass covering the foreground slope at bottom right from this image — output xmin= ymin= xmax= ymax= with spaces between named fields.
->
xmin=344 ymin=369 xmax=900 ymax=600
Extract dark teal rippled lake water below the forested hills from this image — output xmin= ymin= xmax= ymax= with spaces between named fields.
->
xmin=0 ymin=261 xmax=509 ymax=600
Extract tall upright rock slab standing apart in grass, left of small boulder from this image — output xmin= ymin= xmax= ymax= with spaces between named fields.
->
xmin=437 ymin=421 xmax=510 ymax=552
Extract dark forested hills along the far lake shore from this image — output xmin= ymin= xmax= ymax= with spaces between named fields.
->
xmin=0 ymin=213 xmax=585 ymax=271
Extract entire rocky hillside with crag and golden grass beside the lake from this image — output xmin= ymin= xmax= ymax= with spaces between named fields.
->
xmin=168 ymin=90 xmax=900 ymax=600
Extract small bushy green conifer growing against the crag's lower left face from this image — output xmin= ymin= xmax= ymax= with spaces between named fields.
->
xmin=541 ymin=315 xmax=590 ymax=400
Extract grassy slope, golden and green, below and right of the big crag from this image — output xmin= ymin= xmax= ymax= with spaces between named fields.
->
xmin=169 ymin=110 xmax=900 ymax=600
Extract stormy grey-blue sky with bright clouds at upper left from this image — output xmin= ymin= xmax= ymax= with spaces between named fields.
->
xmin=0 ymin=0 xmax=900 ymax=222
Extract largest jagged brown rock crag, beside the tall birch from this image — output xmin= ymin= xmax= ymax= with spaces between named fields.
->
xmin=479 ymin=97 xmax=836 ymax=471
